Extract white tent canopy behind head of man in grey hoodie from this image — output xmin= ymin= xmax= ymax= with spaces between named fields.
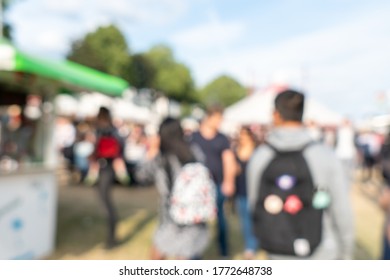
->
xmin=222 ymin=85 xmax=343 ymax=131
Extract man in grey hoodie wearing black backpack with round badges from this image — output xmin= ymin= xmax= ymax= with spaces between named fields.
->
xmin=247 ymin=90 xmax=354 ymax=260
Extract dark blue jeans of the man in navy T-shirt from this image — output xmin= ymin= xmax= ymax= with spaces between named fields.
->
xmin=217 ymin=185 xmax=229 ymax=257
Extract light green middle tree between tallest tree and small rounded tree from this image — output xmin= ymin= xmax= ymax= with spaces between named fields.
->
xmin=145 ymin=45 xmax=196 ymax=102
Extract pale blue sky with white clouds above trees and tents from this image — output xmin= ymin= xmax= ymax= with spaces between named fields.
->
xmin=5 ymin=0 xmax=390 ymax=119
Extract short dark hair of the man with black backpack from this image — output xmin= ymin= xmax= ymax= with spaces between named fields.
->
xmin=275 ymin=89 xmax=305 ymax=122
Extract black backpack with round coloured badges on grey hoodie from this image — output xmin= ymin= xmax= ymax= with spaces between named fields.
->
xmin=253 ymin=143 xmax=329 ymax=257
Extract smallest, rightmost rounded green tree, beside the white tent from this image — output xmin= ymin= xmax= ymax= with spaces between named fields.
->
xmin=199 ymin=75 xmax=247 ymax=107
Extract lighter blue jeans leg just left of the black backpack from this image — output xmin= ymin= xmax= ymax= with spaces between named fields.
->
xmin=236 ymin=195 xmax=258 ymax=252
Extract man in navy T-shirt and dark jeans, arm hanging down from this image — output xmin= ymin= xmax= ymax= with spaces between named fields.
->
xmin=190 ymin=106 xmax=236 ymax=258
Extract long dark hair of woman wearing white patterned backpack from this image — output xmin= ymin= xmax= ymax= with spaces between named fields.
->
xmin=159 ymin=117 xmax=195 ymax=164
